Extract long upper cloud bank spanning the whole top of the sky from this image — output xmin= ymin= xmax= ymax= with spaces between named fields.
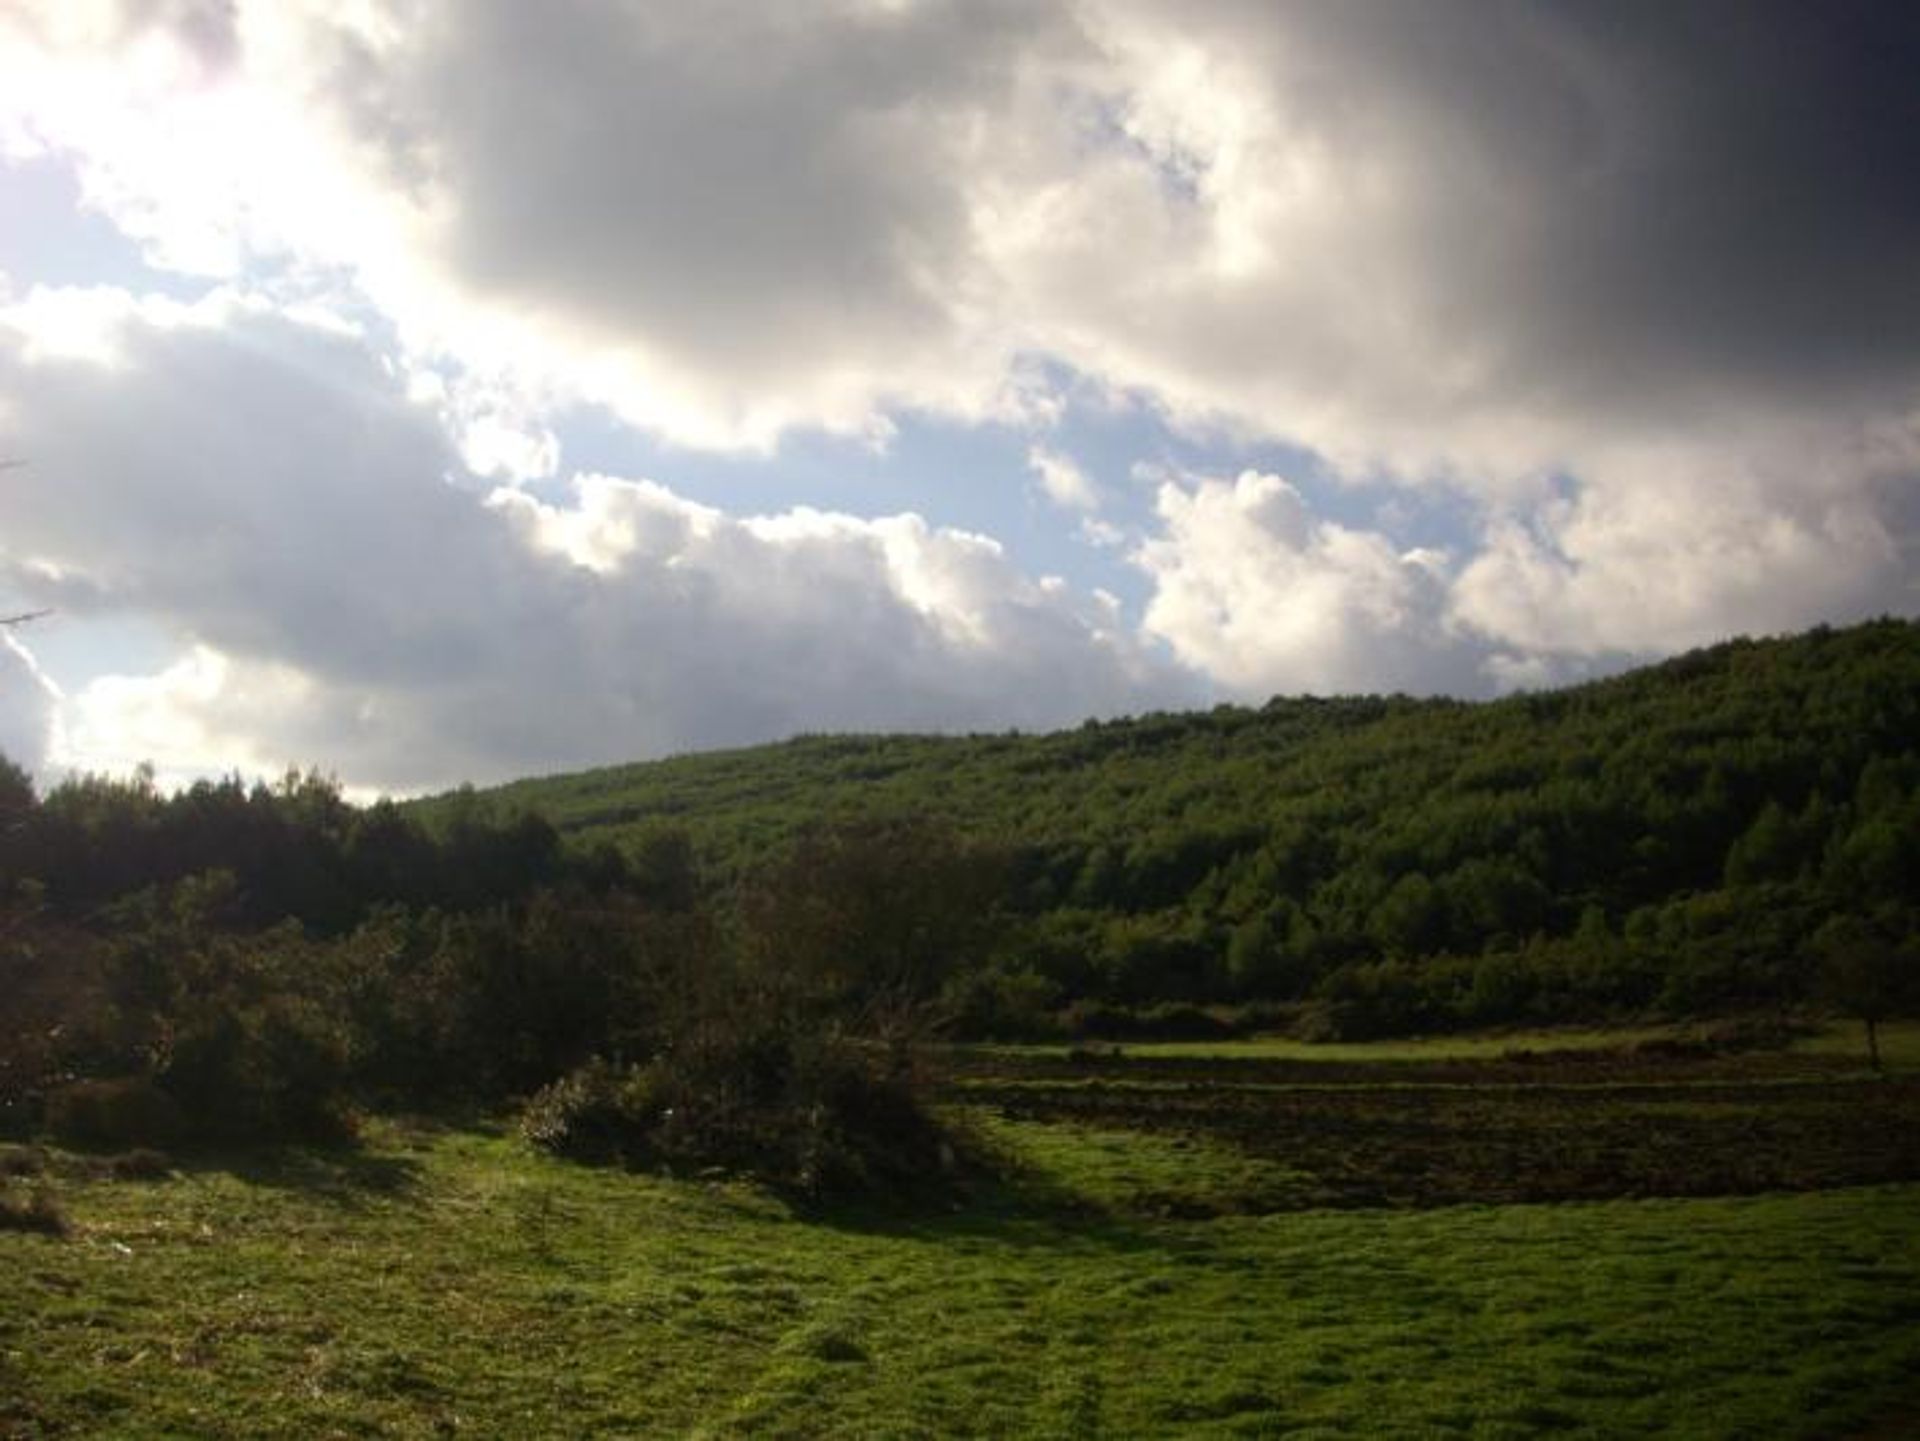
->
xmin=0 ymin=0 xmax=1920 ymax=462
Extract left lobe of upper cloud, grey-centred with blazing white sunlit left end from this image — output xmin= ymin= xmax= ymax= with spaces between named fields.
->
xmin=0 ymin=0 xmax=1075 ymax=447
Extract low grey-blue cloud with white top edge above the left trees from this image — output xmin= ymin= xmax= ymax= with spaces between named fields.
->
xmin=0 ymin=295 xmax=1192 ymax=789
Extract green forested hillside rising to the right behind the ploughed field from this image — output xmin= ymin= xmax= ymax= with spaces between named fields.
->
xmin=420 ymin=620 xmax=1920 ymax=1032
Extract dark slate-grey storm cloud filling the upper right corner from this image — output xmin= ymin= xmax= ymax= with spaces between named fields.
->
xmin=1121 ymin=0 xmax=1920 ymax=427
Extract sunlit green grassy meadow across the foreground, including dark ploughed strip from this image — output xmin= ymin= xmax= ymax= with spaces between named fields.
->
xmin=0 ymin=1028 xmax=1920 ymax=1439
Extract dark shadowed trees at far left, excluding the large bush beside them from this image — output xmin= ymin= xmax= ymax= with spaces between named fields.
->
xmin=0 ymin=764 xmax=659 ymax=1134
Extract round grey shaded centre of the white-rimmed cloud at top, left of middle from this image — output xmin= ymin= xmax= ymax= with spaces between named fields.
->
xmin=312 ymin=0 xmax=1062 ymax=414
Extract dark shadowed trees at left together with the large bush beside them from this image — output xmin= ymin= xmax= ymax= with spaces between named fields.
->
xmin=0 ymin=764 xmax=1000 ymax=1193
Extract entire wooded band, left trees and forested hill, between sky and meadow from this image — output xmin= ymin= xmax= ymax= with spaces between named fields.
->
xmin=0 ymin=622 xmax=1920 ymax=1176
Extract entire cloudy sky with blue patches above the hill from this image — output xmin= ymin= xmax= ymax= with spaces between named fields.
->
xmin=0 ymin=0 xmax=1920 ymax=796
